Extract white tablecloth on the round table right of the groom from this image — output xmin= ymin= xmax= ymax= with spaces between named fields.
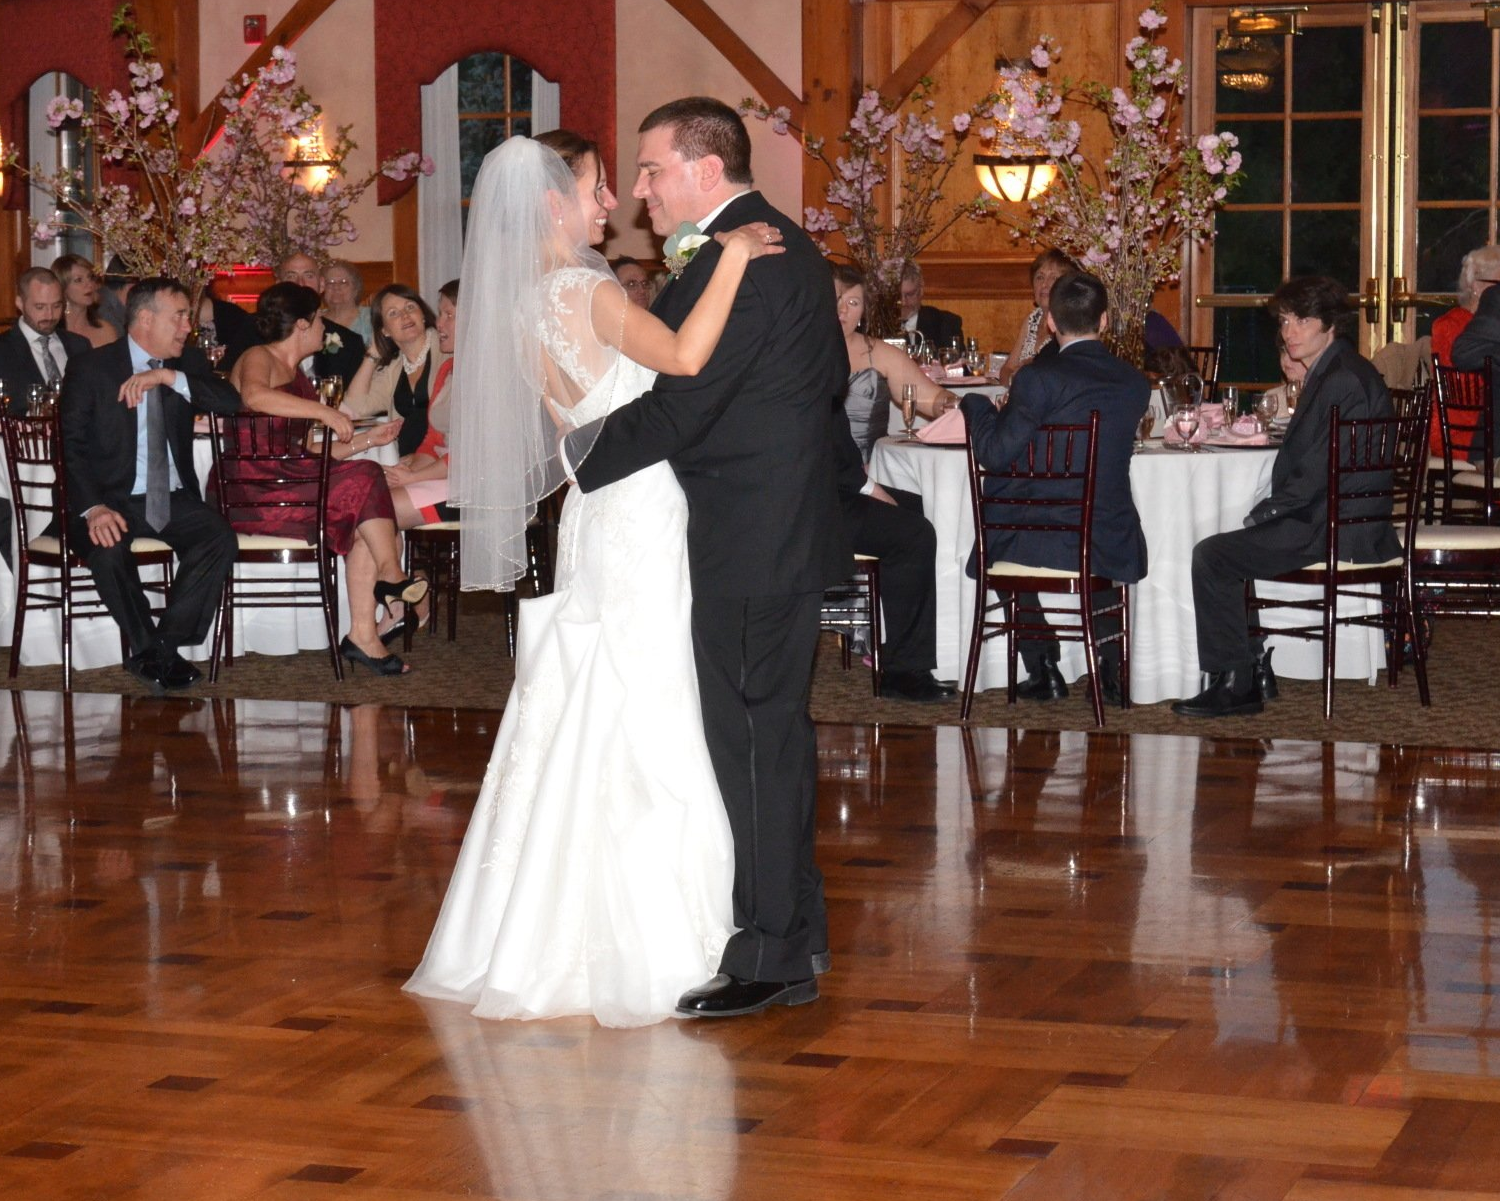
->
xmin=870 ymin=438 xmax=1385 ymax=703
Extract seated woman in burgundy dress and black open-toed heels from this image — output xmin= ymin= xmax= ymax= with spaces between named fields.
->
xmin=219 ymin=283 xmax=428 ymax=676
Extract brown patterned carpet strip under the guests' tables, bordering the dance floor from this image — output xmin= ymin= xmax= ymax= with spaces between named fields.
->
xmin=9 ymin=594 xmax=1500 ymax=750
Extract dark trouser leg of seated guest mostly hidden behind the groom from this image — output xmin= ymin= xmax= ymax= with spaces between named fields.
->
xmin=851 ymin=496 xmax=938 ymax=672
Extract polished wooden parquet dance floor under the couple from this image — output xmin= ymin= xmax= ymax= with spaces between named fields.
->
xmin=0 ymin=693 xmax=1500 ymax=1201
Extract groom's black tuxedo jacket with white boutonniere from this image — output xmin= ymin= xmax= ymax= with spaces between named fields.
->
xmin=570 ymin=192 xmax=854 ymax=597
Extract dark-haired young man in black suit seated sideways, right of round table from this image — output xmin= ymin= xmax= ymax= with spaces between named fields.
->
xmin=1172 ymin=276 xmax=1401 ymax=717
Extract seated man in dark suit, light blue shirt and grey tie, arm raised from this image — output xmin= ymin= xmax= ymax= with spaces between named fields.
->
xmin=60 ymin=279 xmax=240 ymax=688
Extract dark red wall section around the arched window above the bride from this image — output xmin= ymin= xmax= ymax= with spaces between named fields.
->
xmin=375 ymin=0 xmax=615 ymax=204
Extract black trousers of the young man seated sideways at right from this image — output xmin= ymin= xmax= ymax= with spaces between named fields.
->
xmin=1193 ymin=519 xmax=1323 ymax=673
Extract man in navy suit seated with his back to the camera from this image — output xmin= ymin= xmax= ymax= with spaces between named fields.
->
xmin=959 ymin=271 xmax=1151 ymax=705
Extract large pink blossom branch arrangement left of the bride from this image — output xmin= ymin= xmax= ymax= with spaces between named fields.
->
xmin=3 ymin=4 xmax=432 ymax=294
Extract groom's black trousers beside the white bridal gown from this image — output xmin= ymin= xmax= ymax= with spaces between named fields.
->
xmin=693 ymin=592 xmax=828 ymax=981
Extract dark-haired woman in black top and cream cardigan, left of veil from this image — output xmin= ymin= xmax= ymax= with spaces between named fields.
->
xmin=344 ymin=283 xmax=444 ymax=456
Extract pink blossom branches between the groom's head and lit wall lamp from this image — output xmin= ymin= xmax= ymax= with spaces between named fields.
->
xmin=740 ymin=78 xmax=995 ymax=334
